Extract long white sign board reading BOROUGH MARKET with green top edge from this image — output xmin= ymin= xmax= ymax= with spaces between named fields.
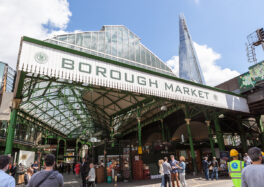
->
xmin=18 ymin=38 xmax=249 ymax=112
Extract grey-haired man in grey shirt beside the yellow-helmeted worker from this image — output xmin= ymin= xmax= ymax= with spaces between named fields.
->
xmin=241 ymin=147 xmax=264 ymax=187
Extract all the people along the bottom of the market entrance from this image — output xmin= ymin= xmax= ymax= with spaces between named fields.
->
xmin=0 ymin=147 xmax=264 ymax=187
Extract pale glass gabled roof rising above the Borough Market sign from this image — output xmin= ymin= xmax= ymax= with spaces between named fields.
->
xmin=46 ymin=25 xmax=175 ymax=76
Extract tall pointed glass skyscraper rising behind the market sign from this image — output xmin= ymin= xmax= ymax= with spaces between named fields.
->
xmin=179 ymin=15 xmax=205 ymax=84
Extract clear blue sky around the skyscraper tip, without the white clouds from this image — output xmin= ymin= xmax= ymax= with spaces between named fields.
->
xmin=64 ymin=0 xmax=264 ymax=73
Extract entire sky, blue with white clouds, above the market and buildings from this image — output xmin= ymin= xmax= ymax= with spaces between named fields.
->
xmin=0 ymin=0 xmax=264 ymax=85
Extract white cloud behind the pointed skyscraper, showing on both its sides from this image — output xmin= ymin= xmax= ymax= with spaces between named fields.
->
xmin=166 ymin=42 xmax=240 ymax=86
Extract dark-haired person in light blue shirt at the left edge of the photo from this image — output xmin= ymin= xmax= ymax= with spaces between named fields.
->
xmin=0 ymin=155 xmax=16 ymax=187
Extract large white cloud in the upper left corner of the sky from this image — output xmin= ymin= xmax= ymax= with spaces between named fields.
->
xmin=0 ymin=0 xmax=71 ymax=68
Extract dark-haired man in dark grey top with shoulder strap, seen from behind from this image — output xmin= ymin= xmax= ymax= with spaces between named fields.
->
xmin=27 ymin=154 xmax=63 ymax=187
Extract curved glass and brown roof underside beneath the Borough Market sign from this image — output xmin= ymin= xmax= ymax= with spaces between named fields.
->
xmin=19 ymin=73 xmax=161 ymax=138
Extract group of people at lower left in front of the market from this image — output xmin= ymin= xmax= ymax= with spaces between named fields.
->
xmin=0 ymin=154 xmax=96 ymax=187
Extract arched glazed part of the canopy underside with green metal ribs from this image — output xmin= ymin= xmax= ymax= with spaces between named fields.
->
xmin=20 ymin=75 xmax=95 ymax=135
